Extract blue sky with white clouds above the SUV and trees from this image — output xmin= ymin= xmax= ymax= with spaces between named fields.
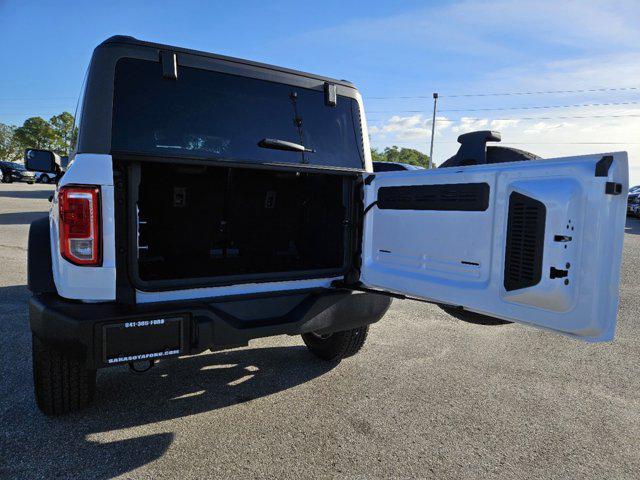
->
xmin=0 ymin=0 xmax=640 ymax=183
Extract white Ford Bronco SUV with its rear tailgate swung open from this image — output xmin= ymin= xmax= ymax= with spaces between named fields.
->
xmin=26 ymin=36 xmax=628 ymax=415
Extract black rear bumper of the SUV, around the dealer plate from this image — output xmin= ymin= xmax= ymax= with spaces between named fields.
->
xmin=29 ymin=289 xmax=391 ymax=368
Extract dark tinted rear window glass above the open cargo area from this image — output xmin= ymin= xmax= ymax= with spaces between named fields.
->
xmin=112 ymin=58 xmax=363 ymax=169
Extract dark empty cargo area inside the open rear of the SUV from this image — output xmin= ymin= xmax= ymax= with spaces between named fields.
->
xmin=132 ymin=162 xmax=357 ymax=286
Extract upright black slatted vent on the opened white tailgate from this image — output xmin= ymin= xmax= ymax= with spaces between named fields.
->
xmin=504 ymin=192 xmax=547 ymax=291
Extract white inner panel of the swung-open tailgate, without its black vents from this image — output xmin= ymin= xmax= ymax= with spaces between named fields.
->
xmin=361 ymin=153 xmax=628 ymax=341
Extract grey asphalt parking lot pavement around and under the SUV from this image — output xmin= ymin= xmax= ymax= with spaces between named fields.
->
xmin=0 ymin=184 xmax=640 ymax=479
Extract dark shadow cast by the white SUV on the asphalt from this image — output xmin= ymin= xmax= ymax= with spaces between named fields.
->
xmin=0 ymin=286 xmax=334 ymax=479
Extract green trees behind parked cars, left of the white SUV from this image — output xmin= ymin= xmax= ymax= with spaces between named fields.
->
xmin=0 ymin=112 xmax=74 ymax=162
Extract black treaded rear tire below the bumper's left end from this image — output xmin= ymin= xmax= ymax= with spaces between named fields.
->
xmin=32 ymin=335 xmax=96 ymax=415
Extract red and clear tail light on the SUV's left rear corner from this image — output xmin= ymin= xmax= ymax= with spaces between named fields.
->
xmin=58 ymin=186 xmax=102 ymax=266
